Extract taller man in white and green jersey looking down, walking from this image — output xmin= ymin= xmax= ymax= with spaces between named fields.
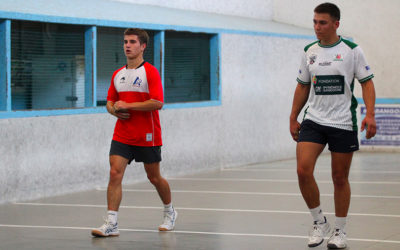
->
xmin=290 ymin=3 xmax=376 ymax=249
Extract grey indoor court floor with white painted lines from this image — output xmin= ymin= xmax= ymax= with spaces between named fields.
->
xmin=0 ymin=152 xmax=400 ymax=250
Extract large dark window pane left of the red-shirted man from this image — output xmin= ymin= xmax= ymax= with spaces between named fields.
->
xmin=11 ymin=21 xmax=85 ymax=110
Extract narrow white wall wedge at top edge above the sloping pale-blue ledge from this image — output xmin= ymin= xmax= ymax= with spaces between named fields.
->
xmin=114 ymin=0 xmax=273 ymax=20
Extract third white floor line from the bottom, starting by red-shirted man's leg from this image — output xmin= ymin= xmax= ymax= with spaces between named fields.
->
xmin=104 ymin=188 xmax=400 ymax=199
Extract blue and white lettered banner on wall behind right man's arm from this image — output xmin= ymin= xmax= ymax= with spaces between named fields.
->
xmin=360 ymin=105 xmax=400 ymax=147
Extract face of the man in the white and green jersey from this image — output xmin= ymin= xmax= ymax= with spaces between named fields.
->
xmin=313 ymin=13 xmax=339 ymax=41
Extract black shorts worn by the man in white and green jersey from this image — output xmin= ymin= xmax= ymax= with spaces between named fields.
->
xmin=298 ymin=120 xmax=359 ymax=153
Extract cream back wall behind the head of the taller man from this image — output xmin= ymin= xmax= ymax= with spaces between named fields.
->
xmin=273 ymin=0 xmax=400 ymax=98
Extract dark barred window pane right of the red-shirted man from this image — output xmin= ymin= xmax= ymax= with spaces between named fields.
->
xmin=164 ymin=31 xmax=211 ymax=103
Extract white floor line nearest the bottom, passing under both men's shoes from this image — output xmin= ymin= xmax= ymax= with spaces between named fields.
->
xmin=0 ymin=224 xmax=400 ymax=244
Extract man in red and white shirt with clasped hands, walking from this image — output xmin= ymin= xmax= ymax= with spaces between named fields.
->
xmin=92 ymin=29 xmax=178 ymax=237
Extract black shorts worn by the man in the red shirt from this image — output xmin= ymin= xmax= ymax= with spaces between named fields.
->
xmin=110 ymin=140 xmax=161 ymax=164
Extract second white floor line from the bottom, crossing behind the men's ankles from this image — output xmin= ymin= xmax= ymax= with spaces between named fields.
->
xmin=13 ymin=202 xmax=400 ymax=218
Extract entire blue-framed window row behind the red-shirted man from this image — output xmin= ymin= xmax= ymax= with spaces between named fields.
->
xmin=0 ymin=19 xmax=220 ymax=118
